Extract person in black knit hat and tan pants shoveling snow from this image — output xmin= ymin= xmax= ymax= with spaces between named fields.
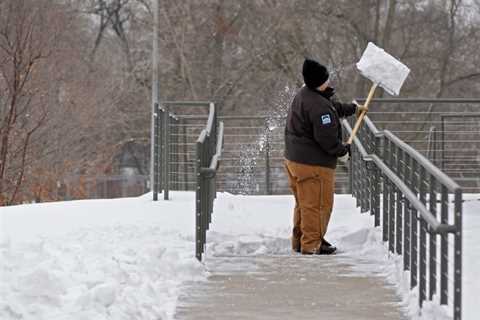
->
xmin=285 ymin=59 xmax=363 ymax=254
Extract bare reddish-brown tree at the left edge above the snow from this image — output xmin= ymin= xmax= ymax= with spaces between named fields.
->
xmin=0 ymin=0 xmax=65 ymax=205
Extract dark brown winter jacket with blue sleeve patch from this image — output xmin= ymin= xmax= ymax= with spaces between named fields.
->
xmin=285 ymin=86 xmax=356 ymax=168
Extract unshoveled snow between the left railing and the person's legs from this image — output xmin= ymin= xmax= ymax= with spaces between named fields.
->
xmin=206 ymin=193 xmax=292 ymax=257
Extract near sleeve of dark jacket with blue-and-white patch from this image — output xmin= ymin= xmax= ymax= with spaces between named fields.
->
xmin=311 ymin=112 xmax=348 ymax=157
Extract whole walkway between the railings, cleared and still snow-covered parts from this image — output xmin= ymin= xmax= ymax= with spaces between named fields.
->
xmin=176 ymin=195 xmax=409 ymax=320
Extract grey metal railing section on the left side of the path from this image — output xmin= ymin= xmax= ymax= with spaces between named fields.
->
xmin=153 ymin=101 xmax=224 ymax=260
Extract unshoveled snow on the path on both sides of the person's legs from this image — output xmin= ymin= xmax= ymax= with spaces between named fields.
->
xmin=207 ymin=190 xmax=376 ymax=256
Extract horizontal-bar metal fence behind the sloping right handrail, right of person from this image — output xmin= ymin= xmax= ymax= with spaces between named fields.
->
xmin=358 ymin=98 xmax=480 ymax=193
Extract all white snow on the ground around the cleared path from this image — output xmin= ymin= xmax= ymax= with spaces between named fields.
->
xmin=0 ymin=192 xmax=480 ymax=320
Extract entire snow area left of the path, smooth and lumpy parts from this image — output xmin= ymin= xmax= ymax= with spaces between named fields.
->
xmin=0 ymin=194 xmax=205 ymax=320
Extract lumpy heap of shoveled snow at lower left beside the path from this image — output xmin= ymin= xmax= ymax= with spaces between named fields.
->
xmin=0 ymin=227 xmax=203 ymax=319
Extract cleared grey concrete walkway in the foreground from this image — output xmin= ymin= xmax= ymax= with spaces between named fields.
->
xmin=175 ymin=254 xmax=408 ymax=320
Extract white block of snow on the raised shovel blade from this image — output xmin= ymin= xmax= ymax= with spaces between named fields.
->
xmin=357 ymin=42 xmax=410 ymax=96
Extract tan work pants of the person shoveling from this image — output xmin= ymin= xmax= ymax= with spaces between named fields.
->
xmin=285 ymin=160 xmax=335 ymax=253
